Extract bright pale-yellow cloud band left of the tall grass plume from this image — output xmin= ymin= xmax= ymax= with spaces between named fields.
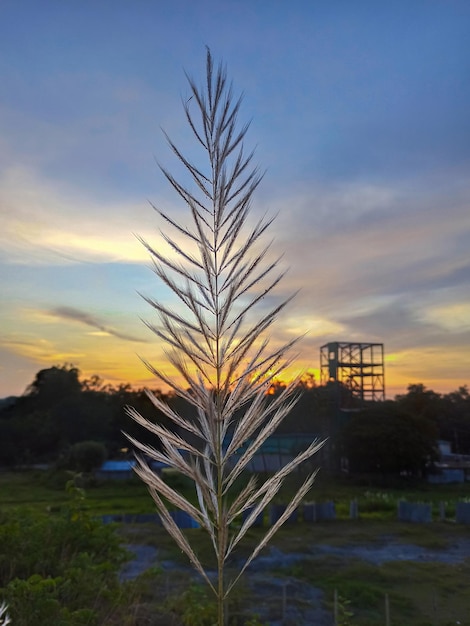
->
xmin=0 ymin=166 xmax=180 ymax=265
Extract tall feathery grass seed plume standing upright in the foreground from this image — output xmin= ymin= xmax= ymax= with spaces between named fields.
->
xmin=125 ymin=51 xmax=320 ymax=626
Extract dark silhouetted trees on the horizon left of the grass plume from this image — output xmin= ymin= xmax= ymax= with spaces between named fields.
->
xmin=0 ymin=365 xmax=176 ymax=466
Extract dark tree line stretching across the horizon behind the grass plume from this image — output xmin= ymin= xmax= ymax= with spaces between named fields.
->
xmin=0 ymin=365 xmax=470 ymax=473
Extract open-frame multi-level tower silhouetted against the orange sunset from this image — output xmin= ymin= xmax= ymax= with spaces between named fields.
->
xmin=320 ymin=341 xmax=385 ymax=404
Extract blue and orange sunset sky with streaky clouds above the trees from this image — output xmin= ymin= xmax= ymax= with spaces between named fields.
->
xmin=0 ymin=0 xmax=470 ymax=397
